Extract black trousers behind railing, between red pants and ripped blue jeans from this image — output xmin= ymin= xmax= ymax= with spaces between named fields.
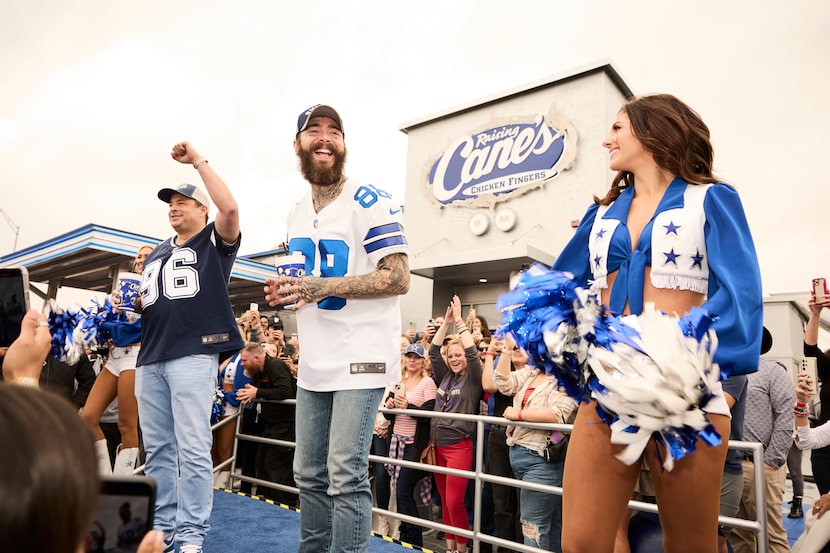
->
xmin=487 ymin=424 xmax=522 ymax=543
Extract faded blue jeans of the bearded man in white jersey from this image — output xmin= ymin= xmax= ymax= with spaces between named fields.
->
xmin=294 ymin=388 xmax=383 ymax=553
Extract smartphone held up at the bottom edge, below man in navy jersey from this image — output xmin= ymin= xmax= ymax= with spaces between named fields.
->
xmin=85 ymin=476 xmax=156 ymax=553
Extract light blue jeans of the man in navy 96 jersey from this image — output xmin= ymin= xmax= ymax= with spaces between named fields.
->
xmin=135 ymin=354 xmax=219 ymax=544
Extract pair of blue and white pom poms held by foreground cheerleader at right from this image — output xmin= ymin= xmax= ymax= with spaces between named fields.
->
xmin=497 ymin=265 xmax=721 ymax=470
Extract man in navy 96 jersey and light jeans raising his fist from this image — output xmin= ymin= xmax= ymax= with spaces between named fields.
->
xmin=135 ymin=142 xmax=244 ymax=553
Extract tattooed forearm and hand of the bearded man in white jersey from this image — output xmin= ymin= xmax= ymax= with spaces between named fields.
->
xmin=265 ymin=253 xmax=409 ymax=309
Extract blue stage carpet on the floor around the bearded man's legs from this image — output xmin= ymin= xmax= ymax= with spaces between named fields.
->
xmin=204 ymin=490 xmax=431 ymax=553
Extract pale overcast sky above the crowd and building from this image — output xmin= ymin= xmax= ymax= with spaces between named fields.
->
xmin=0 ymin=0 xmax=830 ymax=294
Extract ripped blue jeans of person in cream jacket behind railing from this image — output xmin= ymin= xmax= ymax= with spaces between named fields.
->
xmin=510 ymin=445 xmax=565 ymax=551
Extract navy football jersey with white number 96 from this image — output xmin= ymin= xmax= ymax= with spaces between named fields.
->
xmin=136 ymin=223 xmax=245 ymax=366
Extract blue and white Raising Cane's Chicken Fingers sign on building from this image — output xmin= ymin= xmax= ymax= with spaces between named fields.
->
xmin=427 ymin=110 xmax=576 ymax=205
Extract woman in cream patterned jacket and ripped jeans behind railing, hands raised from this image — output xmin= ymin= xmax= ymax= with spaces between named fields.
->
xmin=484 ymin=335 xmax=576 ymax=551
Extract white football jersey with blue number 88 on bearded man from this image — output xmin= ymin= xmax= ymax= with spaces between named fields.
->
xmin=288 ymin=179 xmax=409 ymax=392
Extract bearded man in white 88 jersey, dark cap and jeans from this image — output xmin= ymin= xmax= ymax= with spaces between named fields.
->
xmin=265 ymin=105 xmax=409 ymax=553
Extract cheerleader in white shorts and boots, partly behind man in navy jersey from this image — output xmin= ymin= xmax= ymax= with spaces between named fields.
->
xmin=82 ymin=246 xmax=153 ymax=475
